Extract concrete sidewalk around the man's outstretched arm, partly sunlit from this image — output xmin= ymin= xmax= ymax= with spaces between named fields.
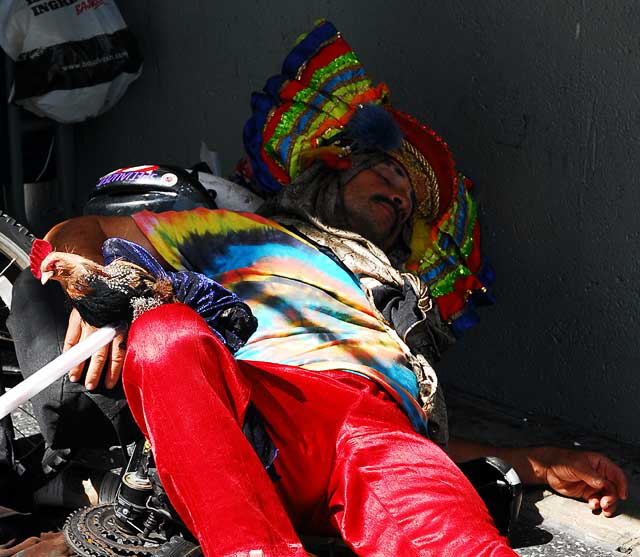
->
xmin=446 ymin=388 xmax=640 ymax=557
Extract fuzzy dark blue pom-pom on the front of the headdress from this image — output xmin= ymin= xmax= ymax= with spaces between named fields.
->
xmin=345 ymin=103 xmax=402 ymax=151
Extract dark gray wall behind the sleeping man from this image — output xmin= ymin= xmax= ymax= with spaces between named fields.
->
xmin=72 ymin=0 xmax=640 ymax=443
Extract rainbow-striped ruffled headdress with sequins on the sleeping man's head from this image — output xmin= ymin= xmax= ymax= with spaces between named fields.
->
xmin=244 ymin=21 xmax=492 ymax=334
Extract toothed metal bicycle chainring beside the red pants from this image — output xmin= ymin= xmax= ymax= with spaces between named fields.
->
xmin=63 ymin=504 xmax=166 ymax=557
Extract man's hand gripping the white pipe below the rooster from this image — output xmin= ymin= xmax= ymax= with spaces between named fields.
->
xmin=63 ymin=309 xmax=125 ymax=391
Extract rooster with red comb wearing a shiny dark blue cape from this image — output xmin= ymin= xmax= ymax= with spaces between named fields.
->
xmin=31 ymin=238 xmax=257 ymax=352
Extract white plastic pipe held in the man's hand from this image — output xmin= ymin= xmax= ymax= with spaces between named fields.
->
xmin=0 ymin=327 xmax=116 ymax=419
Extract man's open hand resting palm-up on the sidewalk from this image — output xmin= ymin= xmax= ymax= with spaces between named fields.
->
xmin=532 ymin=448 xmax=628 ymax=517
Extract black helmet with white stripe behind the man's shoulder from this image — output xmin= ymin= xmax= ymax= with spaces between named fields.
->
xmin=83 ymin=165 xmax=216 ymax=216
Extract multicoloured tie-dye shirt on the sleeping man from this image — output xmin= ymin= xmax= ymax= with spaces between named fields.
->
xmin=133 ymin=209 xmax=426 ymax=432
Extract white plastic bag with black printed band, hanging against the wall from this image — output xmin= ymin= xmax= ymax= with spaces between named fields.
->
xmin=0 ymin=0 xmax=142 ymax=123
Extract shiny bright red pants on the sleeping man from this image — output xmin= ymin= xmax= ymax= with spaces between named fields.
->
xmin=123 ymin=304 xmax=516 ymax=557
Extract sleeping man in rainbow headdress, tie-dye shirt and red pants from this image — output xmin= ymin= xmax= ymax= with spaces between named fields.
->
xmin=6 ymin=22 xmax=626 ymax=557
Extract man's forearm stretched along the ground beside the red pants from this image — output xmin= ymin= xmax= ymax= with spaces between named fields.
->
xmin=448 ymin=439 xmax=555 ymax=484
